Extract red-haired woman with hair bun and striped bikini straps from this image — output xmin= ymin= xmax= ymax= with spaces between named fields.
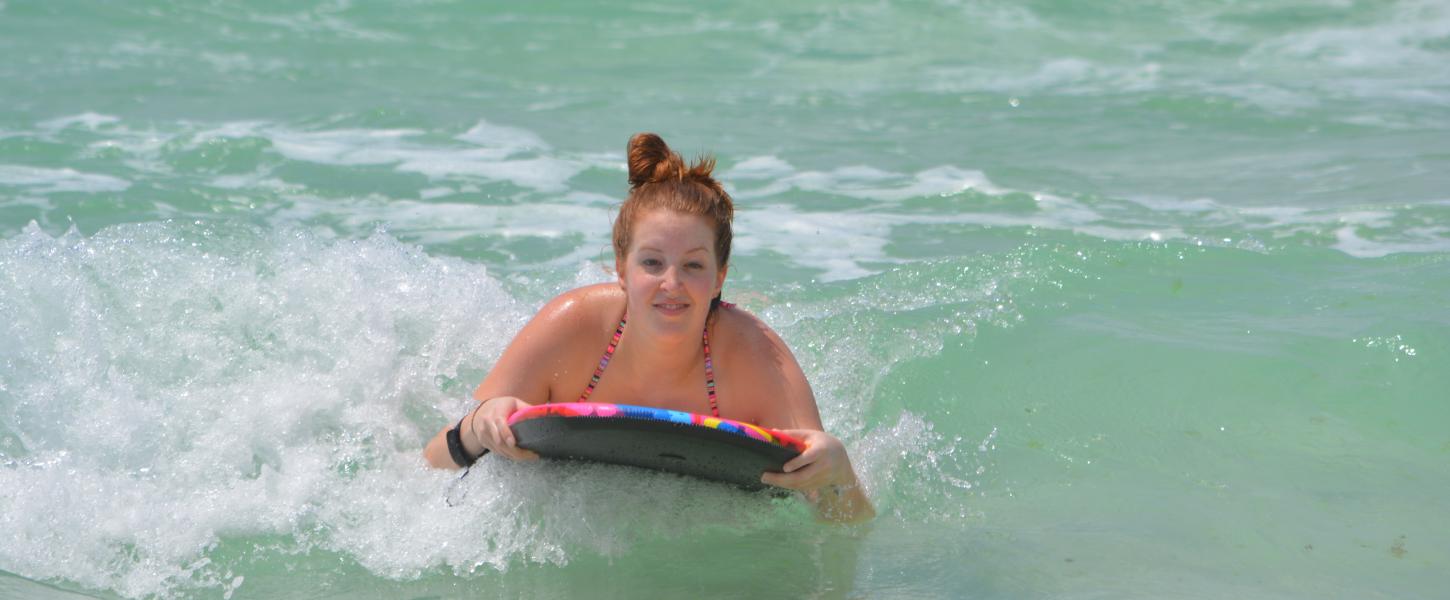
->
xmin=423 ymin=133 xmax=874 ymax=522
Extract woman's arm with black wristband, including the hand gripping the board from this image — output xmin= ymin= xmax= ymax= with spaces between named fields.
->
xmin=423 ymin=288 xmax=595 ymax=468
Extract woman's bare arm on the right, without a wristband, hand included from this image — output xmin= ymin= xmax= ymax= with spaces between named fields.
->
xmin=751 ymin=320 xmax=876 ymax=523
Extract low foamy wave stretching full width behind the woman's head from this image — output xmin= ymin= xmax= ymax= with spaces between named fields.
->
xmin=11 ymin=113 xmax=1450 ymax=281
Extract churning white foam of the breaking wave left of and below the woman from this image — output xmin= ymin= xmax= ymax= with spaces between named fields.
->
xmin=0 ymin=223 xmax=809 ymax=597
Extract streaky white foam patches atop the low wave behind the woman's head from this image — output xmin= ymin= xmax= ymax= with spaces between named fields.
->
xmin=11 ymin=111 xmax=1437 ymax=272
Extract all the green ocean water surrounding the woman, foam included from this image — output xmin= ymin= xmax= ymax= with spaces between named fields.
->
xmin=0 ymin=0 xmax=1450 ymax=599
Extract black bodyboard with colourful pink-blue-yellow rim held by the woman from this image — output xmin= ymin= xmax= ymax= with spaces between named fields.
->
xmin=509 ymin=401 xmax=806 ymax=490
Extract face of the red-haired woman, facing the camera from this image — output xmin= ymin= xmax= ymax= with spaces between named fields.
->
xmin=615 ymin=209 xmax=726 ymax=335
